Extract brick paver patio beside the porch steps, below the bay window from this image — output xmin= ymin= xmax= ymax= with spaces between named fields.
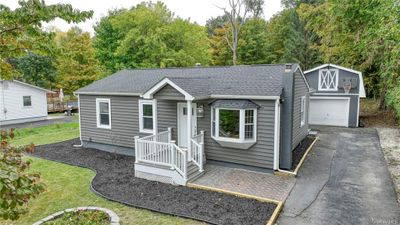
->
xmin=190 ymin=164 xmax=295 ymax=201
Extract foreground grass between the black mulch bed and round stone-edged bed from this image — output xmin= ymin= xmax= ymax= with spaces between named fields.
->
xmin=0 ymin=157 xmax=201 ymax=225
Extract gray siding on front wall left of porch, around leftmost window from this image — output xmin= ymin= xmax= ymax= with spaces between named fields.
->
xmin=79 ymin=95 xmax=145 ymax=149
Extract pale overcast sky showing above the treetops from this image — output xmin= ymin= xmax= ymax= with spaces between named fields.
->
xmin=0 ymin=0 xmax=282 ymax=34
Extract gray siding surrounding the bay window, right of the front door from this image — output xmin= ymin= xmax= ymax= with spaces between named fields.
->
xmin=197 ymin=100 xmax=275 ymax=169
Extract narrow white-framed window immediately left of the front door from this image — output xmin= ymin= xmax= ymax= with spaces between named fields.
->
xmin=139 ymin=100 xmax=156 ymax=133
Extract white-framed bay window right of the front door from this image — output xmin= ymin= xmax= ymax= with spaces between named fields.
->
xmin=211 ymin=107 xmax=257 ymax=143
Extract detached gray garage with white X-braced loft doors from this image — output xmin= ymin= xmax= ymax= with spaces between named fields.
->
xmin=304 ymin=64 xmax=365 ymax=127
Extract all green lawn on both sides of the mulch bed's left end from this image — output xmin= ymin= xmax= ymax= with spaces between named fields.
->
xmin=0 ymin=122 xmax=202 ymax=225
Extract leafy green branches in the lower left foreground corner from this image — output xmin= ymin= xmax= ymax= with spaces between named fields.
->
xmin=0 ymin=130 xmax=45 ymax=220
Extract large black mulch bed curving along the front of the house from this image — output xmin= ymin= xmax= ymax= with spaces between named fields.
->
xmin=33 ymin=140 xmax=276 ymax=225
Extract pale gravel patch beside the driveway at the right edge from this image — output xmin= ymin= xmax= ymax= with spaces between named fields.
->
xmin=376 ymin=128 xmax=400 ymax=203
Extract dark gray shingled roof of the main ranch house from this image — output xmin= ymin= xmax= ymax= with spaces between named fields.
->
xmin=75 ymin=64 xmax=299 ymax=99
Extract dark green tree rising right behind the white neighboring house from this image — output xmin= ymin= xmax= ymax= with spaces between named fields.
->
xmin=12 ymin=52 xmax=57 ymax=89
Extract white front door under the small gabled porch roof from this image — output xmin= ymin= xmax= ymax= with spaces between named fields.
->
xmin=178 ymin=102 xmax=197 ymax=147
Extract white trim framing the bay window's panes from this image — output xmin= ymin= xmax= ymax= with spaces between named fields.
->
xmin=211 ymin=107 xmax=257 ymax=143
